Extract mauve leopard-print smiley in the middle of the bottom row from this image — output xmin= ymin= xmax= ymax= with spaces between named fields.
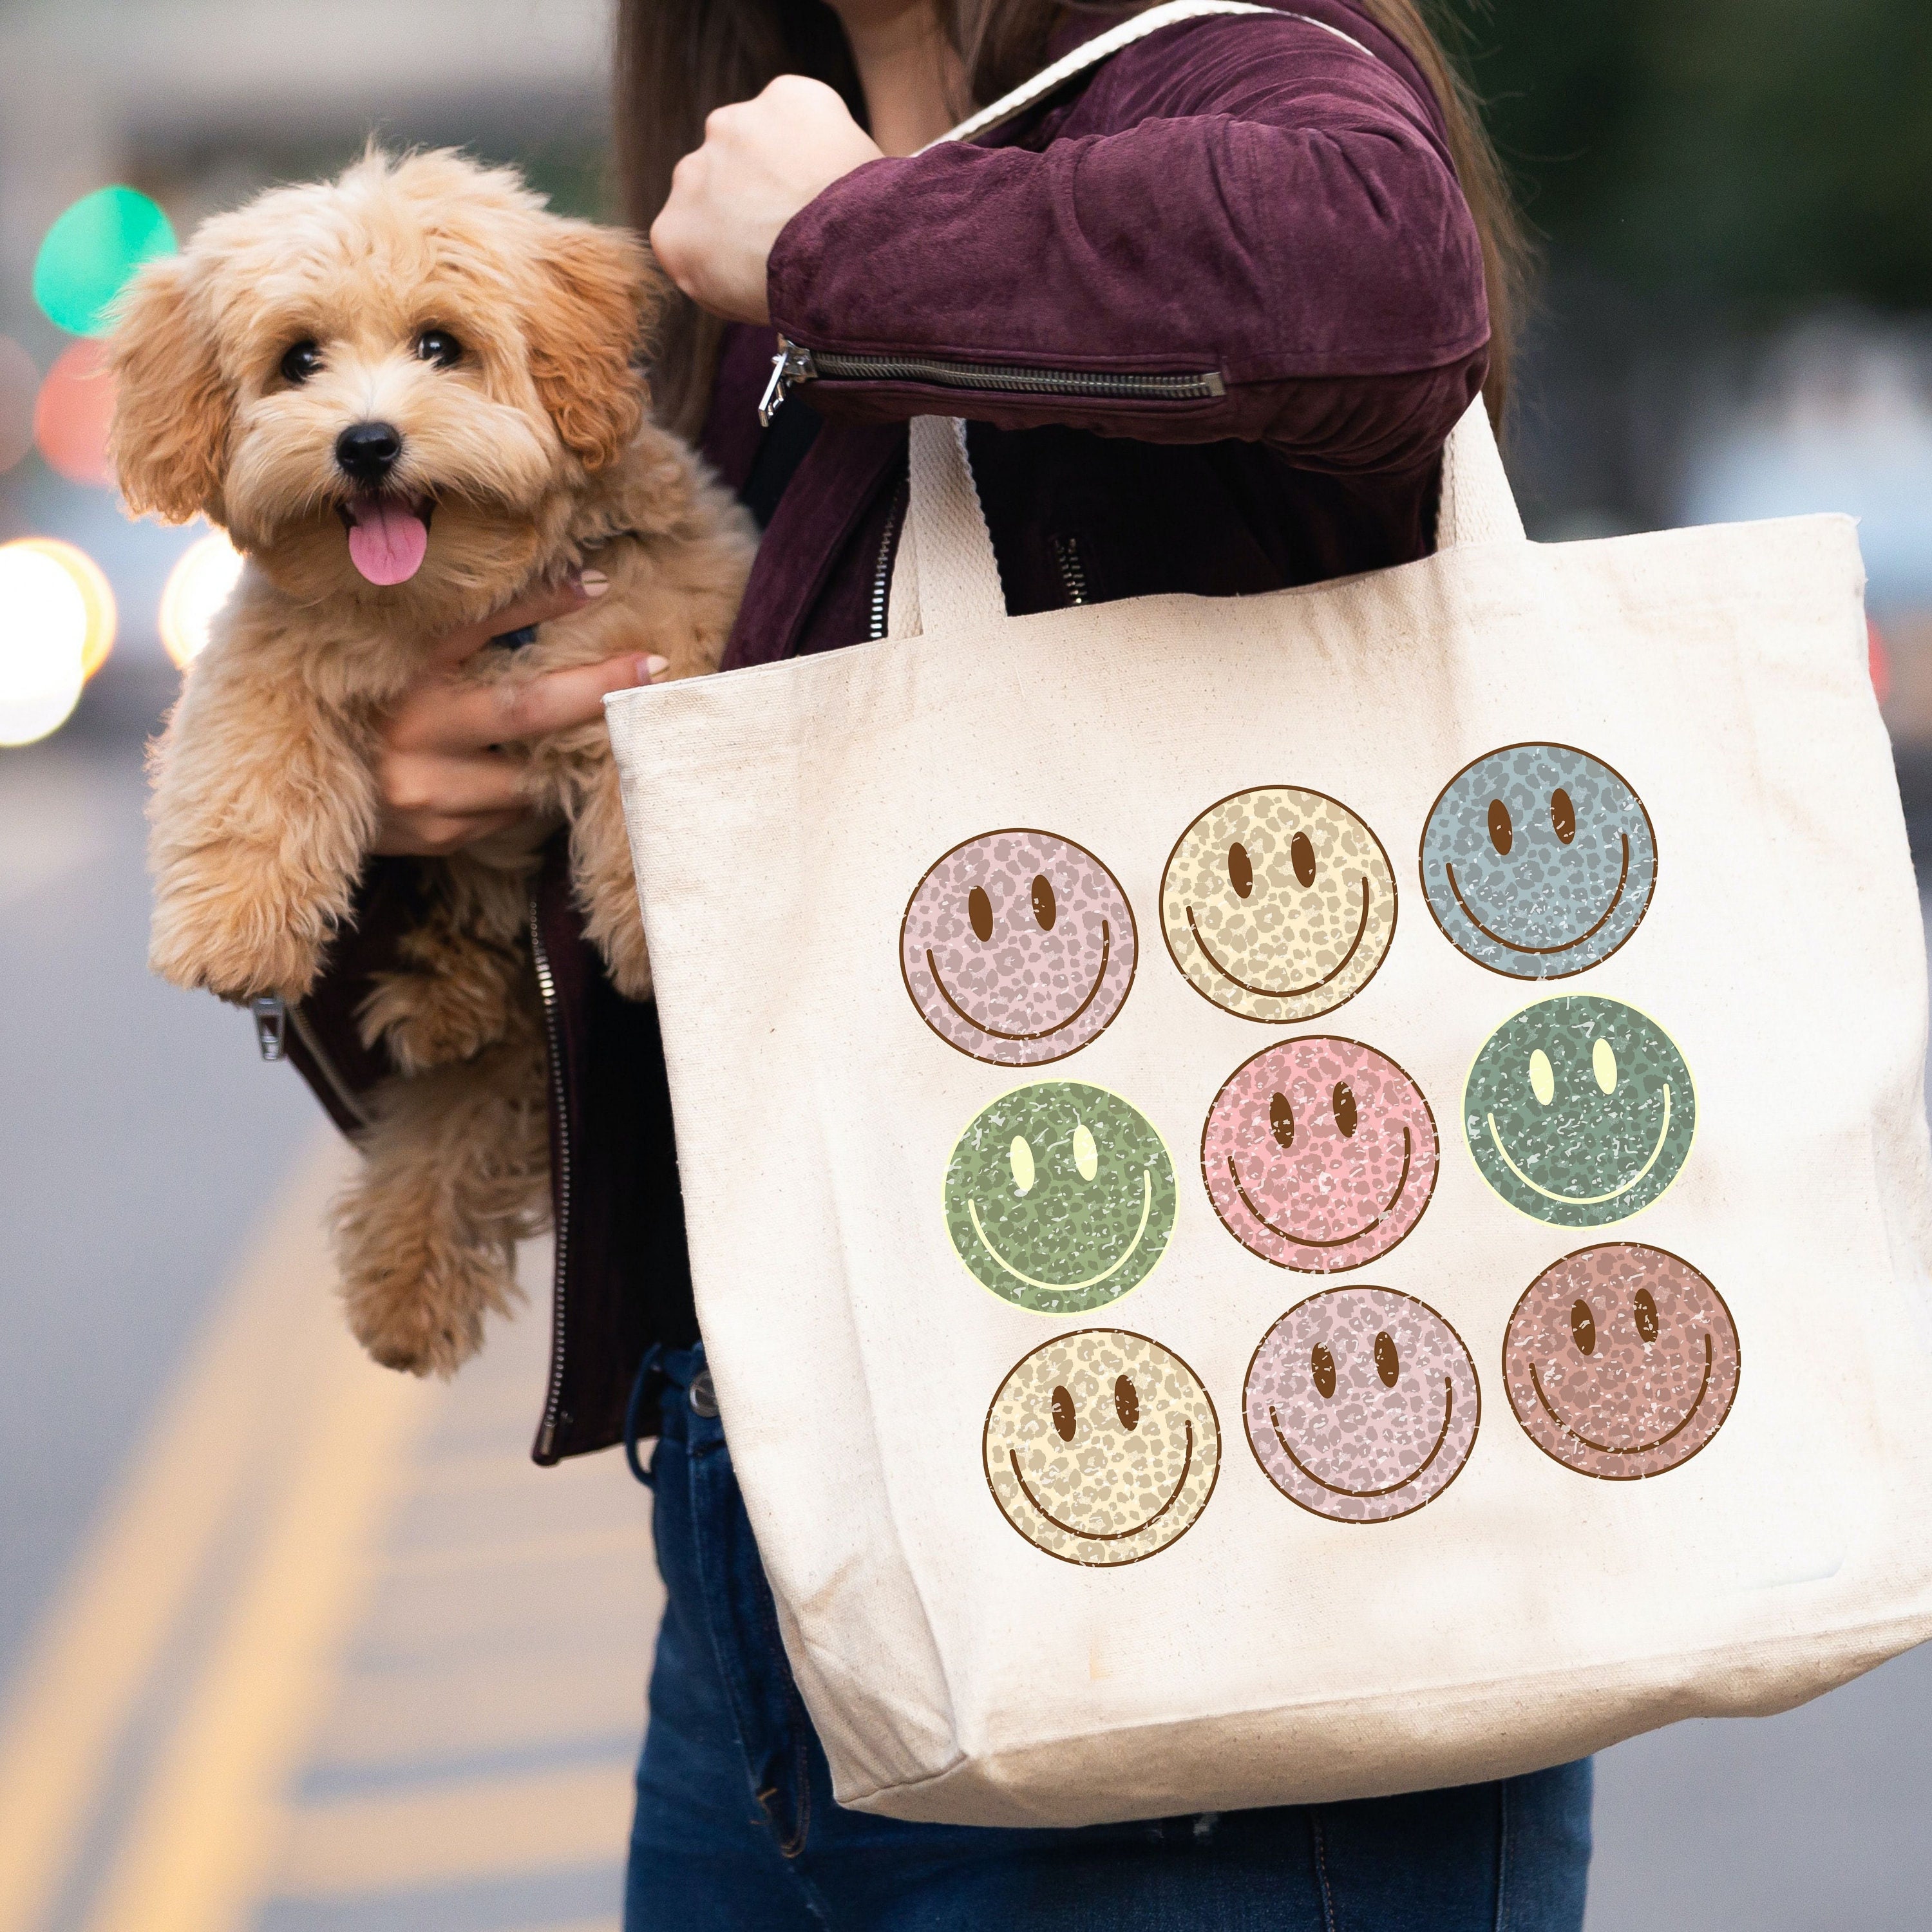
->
xmin=1242 ymin=1289 xmax=1482 ymax=1522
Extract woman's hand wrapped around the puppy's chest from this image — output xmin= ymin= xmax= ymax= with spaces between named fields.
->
xmin=375 ymin=570 xmax=665 ymax=858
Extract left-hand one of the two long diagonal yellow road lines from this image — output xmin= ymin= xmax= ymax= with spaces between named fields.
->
xmin=0 ymin=1138 xmax=355 ymax=1932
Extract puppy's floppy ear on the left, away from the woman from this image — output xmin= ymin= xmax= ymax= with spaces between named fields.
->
xmin=108 ymin=255 xmax=232 ymax=524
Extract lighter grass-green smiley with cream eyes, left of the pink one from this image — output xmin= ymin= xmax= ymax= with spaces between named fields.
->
xmin=947 ymin=1080 xmax=1177 ymax=1316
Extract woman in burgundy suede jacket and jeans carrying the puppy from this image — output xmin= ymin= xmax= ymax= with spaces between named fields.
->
xmin=282 ymin=0 xmax=1590 ymax=1932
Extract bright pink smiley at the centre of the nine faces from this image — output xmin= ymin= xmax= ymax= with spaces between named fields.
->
xmin=1202 ymin=1034 xmax=1441 ymax=1275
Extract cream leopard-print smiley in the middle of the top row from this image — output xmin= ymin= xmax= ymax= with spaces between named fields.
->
xmin=1161 ymin=784 xmax=1395 ymax=1026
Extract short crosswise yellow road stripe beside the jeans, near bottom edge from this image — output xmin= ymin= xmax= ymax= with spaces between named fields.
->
xmin=276 ymin=1762 xmax=632 ymax=1897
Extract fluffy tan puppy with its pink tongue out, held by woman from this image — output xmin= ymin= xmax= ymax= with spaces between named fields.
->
xmin=114 ymin=153 xmax=752 ymax=1374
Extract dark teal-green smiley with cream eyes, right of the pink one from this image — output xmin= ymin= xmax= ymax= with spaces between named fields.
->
xmin=1463 ymin=993 xmax=1696 ymax=1227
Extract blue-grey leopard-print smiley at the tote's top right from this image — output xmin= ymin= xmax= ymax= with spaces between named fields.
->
xmin=1422 ymin=744 xmax=1658 ymax=980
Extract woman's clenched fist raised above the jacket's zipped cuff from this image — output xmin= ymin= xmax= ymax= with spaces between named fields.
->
xmin=651 ymin=73 xmax=881 ymax=323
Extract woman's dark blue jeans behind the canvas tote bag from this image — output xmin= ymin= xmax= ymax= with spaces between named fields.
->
xmin=624 ymin=1349 xmax=1590 ymax=1932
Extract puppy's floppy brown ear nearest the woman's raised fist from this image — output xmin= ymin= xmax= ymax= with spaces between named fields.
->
xmin=526 ymin=222 xmax=663 ymax=469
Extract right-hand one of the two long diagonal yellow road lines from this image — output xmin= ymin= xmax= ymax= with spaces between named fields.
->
xmin=87 ymin=1267 xmax=440 ymax=1932
